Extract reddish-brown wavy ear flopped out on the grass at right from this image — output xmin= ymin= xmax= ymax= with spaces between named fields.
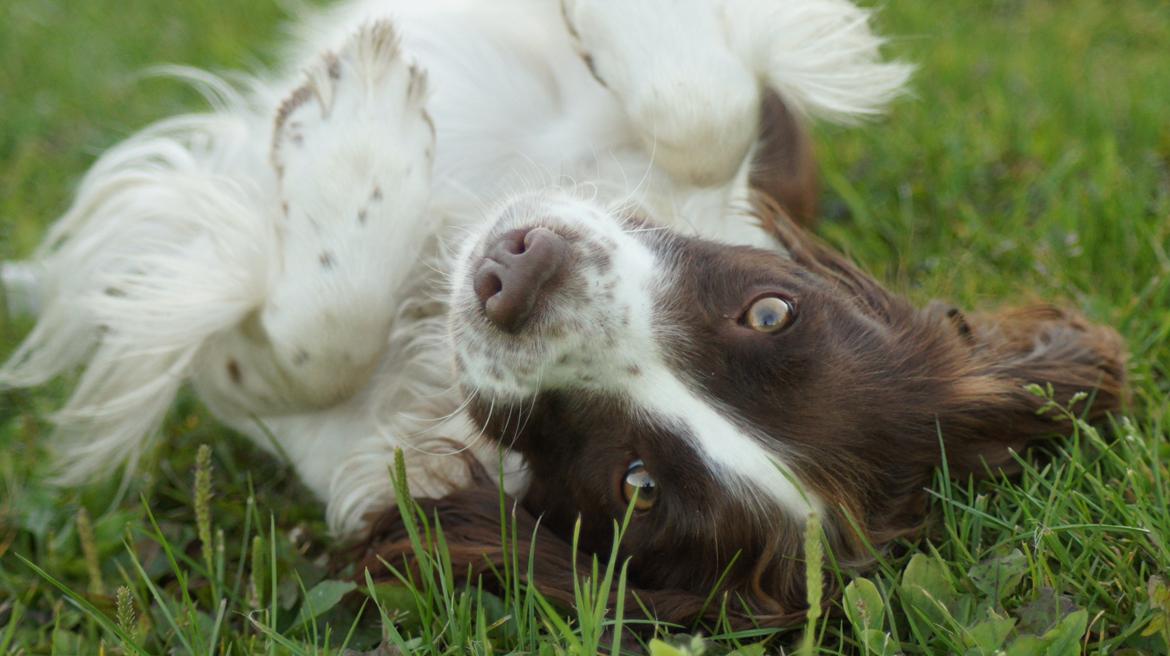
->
xmin=927 ymin=304 xmax=1126 ymax=474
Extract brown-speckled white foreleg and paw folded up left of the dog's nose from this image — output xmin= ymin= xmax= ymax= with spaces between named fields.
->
xmin=261 ymin=21 xmax=434 ymax=403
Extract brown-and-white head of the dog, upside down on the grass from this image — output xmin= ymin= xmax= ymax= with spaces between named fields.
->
xmin=362 ymin=189 xmax=1123 ymax=622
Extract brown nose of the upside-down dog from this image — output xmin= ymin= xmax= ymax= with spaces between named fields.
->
xmin=472 ymin=228 xmax=569 ymax=332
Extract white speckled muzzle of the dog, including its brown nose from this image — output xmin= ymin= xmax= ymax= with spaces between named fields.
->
xmin=449 ymin=195 xmax=662 ymax=402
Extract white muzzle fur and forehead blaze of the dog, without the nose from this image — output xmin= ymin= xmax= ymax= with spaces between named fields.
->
xmin=453 ymin=191 xmax=823 ymax=519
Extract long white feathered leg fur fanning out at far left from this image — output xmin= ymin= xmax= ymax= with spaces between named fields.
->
xmin=0 ymin=109 xmax=274 ymax=483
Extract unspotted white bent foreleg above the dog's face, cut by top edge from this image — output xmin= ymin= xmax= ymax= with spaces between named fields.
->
xmin=562 ymin=0 xmax=762 ymax=186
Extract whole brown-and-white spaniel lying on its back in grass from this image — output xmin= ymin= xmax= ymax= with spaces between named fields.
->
xmin=0 ymin=0 xmax=1123 ymax=622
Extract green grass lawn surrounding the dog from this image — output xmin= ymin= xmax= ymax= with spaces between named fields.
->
xmin=0 ymin=0 xmax=1170 ymax=656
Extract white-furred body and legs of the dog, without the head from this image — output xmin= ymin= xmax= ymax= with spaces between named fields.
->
xmin=0 ymin=0 xmax=908 ymax=534
